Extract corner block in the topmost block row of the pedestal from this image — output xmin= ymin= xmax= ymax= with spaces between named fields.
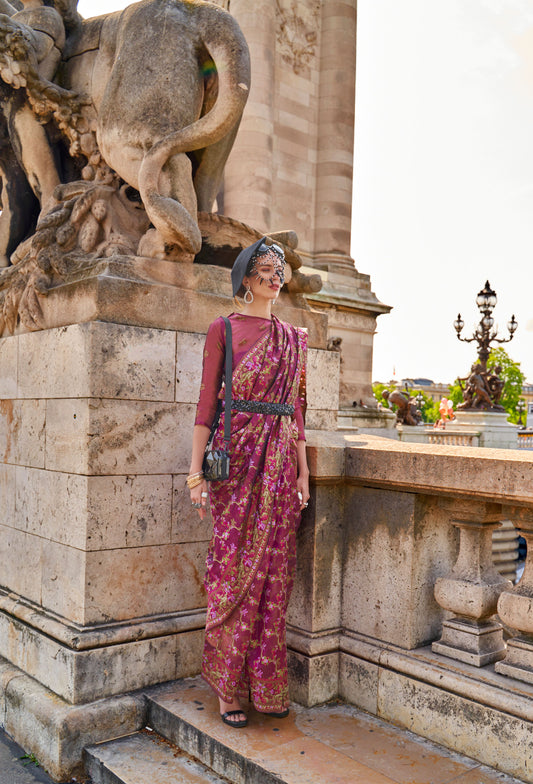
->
xmin=17 ymin=322 xmax=176 ymax=402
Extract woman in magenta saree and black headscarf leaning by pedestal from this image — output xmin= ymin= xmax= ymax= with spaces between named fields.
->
xmin=187 ymin=238 xmax=309 ymax=727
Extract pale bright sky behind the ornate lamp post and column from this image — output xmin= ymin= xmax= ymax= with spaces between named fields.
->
xmin=78 ymin=0 xmax=533 ymax=382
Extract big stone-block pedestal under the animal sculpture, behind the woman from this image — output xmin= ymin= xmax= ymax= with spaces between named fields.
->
xmin=0 ymin=258 xmax=339 ymax=775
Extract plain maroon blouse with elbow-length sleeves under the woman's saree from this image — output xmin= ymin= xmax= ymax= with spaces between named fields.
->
xmin=194 ymin=313 xmax=306 ymax=441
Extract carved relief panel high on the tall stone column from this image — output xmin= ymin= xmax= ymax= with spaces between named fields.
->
xmin=276 ymin=0 xmax=321 ymax=74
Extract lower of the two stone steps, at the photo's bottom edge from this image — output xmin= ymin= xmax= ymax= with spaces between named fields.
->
xmin=85 ymin=730 xmax=228 ymax=784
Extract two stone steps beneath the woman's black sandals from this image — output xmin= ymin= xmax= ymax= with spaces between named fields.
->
xmin=86 ymin=678 xmax=520 ymax=784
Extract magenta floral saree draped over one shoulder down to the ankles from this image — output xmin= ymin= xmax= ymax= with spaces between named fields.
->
xmin=202 ymin=318 xmax=307 ymax=712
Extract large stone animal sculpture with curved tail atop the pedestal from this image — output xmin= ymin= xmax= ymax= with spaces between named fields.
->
xmin=0 ymin=0 xmax=260 ymax=335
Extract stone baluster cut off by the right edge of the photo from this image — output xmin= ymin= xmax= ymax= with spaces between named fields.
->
xmin=496 ymin=507 xmax=533 ymax=683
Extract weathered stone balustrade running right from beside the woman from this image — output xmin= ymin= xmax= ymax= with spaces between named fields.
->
xmin=288 ymin=433 xmax=533 ymax=781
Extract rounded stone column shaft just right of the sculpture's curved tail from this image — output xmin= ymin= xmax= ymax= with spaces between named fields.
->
xmin=223 ymin=0 xmax=276 ymax=232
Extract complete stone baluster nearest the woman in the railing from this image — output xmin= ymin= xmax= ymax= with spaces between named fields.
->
xmin=432 ymin=501 xmax=513 ymax=667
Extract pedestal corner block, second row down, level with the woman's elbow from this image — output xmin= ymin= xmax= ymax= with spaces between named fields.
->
xmin=46 ymin=398 xmax=195 ymax=475
